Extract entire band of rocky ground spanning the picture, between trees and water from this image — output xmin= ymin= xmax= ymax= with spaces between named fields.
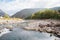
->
xmin=0 ymin=19 xmax=60 ymax=38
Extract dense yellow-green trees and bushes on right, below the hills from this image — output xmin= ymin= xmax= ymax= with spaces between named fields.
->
xmin=31 ymin=9 xmax=60 ymax=19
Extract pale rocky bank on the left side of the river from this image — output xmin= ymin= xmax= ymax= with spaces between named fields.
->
xmin=0 ymin=18 xmax=24 ymax=34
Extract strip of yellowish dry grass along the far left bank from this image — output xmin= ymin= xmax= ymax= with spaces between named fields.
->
xmin=0 ymin=18 xmax=23 ymax=23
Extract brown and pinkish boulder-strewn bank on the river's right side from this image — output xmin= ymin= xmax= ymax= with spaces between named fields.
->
xmin=23 ymin=20 xmax=60 ymax=38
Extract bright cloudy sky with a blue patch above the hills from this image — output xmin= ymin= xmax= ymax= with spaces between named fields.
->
xmin=0 ymin=0 xmax=60 ymax=15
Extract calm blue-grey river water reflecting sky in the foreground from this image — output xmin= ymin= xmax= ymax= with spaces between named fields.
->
xmin=0 ymin=22 xmax=56 ymax=40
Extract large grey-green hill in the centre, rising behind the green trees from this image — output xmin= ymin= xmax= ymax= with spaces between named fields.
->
xmin=12 ymin=8 xmax=42 ymax=18
